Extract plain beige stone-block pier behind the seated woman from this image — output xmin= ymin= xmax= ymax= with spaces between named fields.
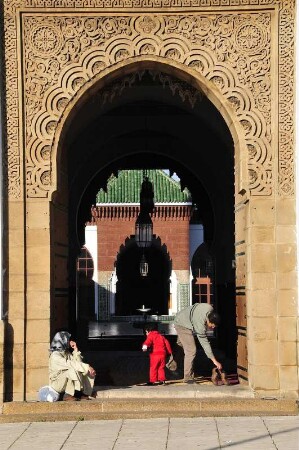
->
xmin=24 ymin=199 xmax=51 ymax=400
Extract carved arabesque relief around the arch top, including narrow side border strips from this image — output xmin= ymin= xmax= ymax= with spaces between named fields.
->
xmin=5 ymin=0 xmax=294 ymax=198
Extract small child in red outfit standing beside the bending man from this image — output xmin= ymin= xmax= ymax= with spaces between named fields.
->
xmin=142 ymin=324 xmax=172 ymax=385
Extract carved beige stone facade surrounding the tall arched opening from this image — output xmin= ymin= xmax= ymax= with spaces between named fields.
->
xmin=0 ymin=0 xmax=299 ymax=401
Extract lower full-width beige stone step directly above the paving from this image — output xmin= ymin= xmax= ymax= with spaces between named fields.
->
xmin=0 ymin=398 xmax=298 ymax=423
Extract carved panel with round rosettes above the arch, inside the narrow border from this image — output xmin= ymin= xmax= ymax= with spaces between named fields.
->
xmin=23 ymin=12 xmax=272 ymax=197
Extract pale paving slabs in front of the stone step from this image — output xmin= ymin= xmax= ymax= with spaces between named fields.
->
xmin=0 ymin=416 xmax=299 ymax=450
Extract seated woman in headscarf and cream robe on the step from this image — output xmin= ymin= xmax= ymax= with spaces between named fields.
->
xmin=49 ymin=331 xmax=96 ymax=400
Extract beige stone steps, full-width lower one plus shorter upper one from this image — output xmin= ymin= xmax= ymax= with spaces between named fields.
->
xmin=0 ymin=386 xmax=298 ymax=423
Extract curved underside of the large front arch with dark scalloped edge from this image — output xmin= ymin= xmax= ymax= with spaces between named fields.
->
xmin=52 ymin=55 xmax=247 ymax=199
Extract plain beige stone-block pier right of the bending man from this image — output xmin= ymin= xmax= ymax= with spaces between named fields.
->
xmin=247 ymin=198 xmax=298 ymax=396
